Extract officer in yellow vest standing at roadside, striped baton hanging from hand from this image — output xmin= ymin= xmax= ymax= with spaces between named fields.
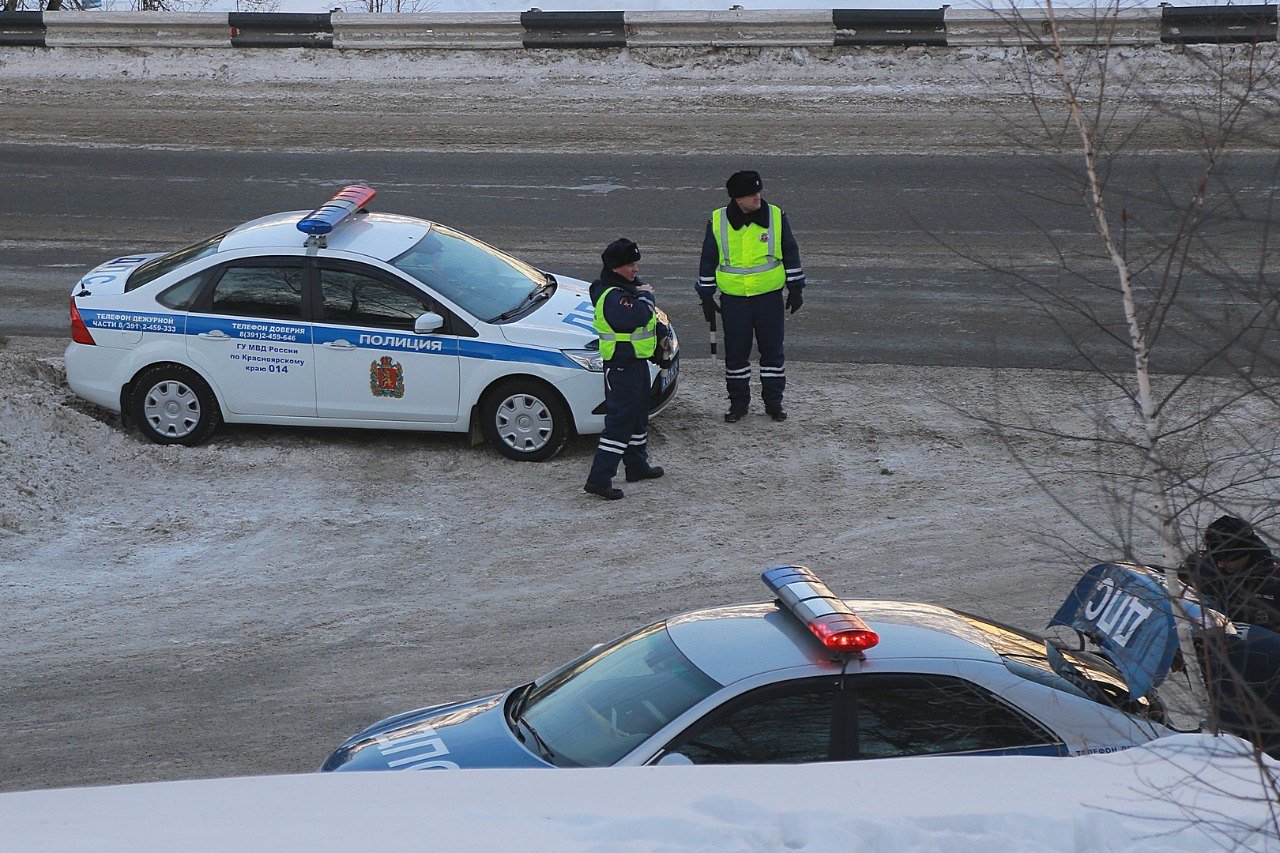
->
xmin=696 ymin=172 xmax=804 ymax=424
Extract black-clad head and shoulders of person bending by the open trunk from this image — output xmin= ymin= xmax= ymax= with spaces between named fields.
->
xmin=1178 ymin=515 xmax=1280 ymax=630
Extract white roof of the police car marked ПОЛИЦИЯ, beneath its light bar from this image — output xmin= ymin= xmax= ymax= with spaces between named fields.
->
xmin=218 ymin=210 xmax=431 ymax=261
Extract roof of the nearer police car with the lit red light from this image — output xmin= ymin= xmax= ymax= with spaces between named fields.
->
xmin=667 ymin=598 xmax=1000 ymax=684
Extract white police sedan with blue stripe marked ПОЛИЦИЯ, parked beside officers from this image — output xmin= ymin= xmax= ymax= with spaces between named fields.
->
xmin=67 ymin=186 xmax=680 ymax=461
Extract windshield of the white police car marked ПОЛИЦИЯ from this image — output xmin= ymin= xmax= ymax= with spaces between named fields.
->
xmin=392 ymin=224 xmax=548 ymax=323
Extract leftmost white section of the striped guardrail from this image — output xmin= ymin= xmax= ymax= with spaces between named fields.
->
xmin=45 ymin=12 xmax=230 ymax=47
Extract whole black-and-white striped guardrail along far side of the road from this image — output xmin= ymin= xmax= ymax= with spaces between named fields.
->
xmin=0 ymin=4 xmax=1277 ymax=50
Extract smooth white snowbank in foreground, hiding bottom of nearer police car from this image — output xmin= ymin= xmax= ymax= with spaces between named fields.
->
xmin=0 ymin=735 xmax=1280 ymax=852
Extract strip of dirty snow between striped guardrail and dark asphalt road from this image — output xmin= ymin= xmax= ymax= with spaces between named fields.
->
xmin=0 ymin=45 xmax=1280 ymax=155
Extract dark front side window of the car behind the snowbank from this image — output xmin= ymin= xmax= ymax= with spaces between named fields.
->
xmin=669 ymin=684 xmax=837 ymax=765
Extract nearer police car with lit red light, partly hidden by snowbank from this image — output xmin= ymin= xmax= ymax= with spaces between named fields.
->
xmin=321 ymin=566 xmax=1169 ymax=771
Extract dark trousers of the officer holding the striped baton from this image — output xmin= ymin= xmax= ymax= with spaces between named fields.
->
xmin=721 ymin=289 xmax=787 ymax=409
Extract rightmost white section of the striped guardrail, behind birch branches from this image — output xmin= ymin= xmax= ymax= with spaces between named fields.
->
xmin=946 ymin=8 xmax=1160 ymax=47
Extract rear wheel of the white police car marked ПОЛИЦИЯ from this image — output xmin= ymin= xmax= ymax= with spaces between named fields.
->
xmin=129 ymin=365 xmax=221 ymax=447
